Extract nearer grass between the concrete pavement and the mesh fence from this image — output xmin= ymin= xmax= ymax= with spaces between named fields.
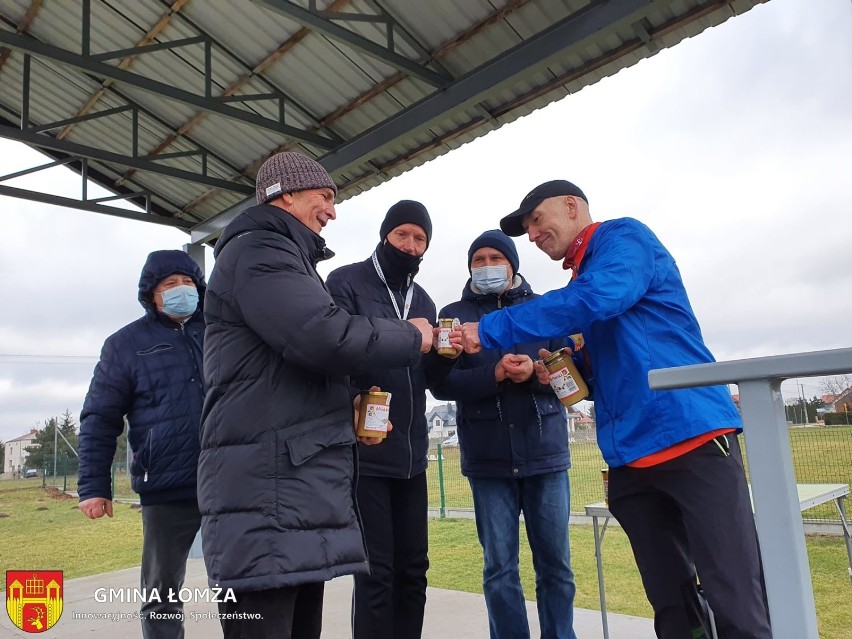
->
xmin=0 ymin=480 xmax=852 ymax=639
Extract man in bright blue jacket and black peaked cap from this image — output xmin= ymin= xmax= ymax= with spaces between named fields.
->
xmin=462 ymin=180 xmax=772 ymax=639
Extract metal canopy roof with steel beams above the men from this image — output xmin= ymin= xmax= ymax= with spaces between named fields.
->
xmin=0 ymin=0 xmax=762 ymax=244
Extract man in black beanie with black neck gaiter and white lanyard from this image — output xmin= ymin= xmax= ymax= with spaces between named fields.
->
xmin=328 ymin=200 xmax=461 ymax=639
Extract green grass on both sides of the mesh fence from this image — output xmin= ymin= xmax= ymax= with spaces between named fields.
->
xmin=8 ymin=427 xmax=852 ymax=639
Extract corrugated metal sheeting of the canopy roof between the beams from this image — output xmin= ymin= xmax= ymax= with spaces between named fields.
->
xmin=0 ymin=0 xmax=760 ymax=232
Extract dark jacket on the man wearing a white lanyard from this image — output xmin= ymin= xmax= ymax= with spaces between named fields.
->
xmin=328 ymin=253 xmax=454 ymax=479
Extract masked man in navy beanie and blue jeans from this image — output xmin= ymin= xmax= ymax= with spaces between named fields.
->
xmin=432 ymin=231 xmax=576 ymax=639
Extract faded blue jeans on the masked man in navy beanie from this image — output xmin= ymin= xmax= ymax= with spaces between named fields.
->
xmin=468 ymin=471 xmax=576 ymax=639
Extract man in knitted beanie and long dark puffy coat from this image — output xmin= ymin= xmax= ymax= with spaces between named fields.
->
xmin=198 ymin=152 xmax=434 ymax=639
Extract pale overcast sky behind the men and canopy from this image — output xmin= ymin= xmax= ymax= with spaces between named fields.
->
xmin=0 ymin=0 xmax=852 ymax=441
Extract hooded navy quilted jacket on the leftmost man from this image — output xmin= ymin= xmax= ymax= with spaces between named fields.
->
xmin=77 ymin=251 xmax=206 ymax=505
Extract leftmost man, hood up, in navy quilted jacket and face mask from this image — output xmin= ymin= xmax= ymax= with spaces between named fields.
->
xmin=77 ymin=251 xmax=205 ymax=639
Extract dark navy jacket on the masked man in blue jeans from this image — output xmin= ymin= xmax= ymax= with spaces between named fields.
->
xmin=432 ymin=275 xmax=571 ymax=478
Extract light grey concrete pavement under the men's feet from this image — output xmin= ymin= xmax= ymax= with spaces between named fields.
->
xmin=0 ymin=559 xmax=655 ymax=639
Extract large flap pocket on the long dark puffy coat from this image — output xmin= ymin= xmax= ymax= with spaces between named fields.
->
xmin=275 ymin=425 xmax=356 ymax=530
